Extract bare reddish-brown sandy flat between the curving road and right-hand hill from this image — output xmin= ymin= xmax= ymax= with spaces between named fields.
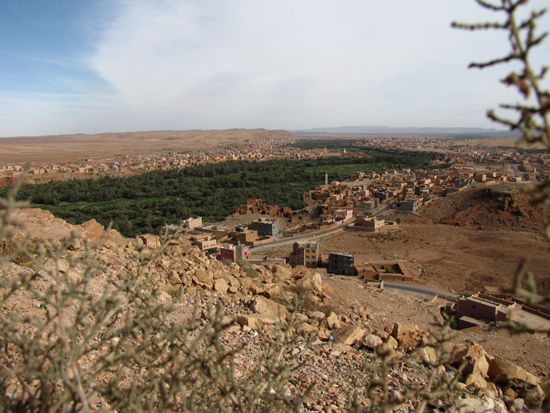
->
xmin=262 ymin=224 xmax=550 ymax=293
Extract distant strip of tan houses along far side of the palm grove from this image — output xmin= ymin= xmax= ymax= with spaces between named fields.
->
xmin=0 ymin=136 xmax=550 ymax=185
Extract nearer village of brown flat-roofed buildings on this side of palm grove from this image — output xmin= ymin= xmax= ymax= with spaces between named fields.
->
xmin=126 ymin=159 xmax=550 ymax=337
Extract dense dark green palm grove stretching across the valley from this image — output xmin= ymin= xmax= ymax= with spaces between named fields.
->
xmin=0 ymin=151 xmax=435 ymax=236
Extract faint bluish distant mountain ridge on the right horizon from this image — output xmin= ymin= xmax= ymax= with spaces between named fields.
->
xmin=288 ymin=126 xmax=514 ymax=135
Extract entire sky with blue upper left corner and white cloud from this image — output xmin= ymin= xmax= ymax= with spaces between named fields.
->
xmin=0 ymin=0 xmax=550 ymax=137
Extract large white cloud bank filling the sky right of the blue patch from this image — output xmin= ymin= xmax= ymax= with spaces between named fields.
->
xmin=4 ymin=0 xmax=550 ymax=136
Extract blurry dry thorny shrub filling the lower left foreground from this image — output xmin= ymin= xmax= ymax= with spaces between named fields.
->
xmin=0 ymin=184 xmax=310 ymax=412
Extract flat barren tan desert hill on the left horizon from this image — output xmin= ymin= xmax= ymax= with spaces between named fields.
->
xmin=0 ymin=129 xmax=293 ymax=164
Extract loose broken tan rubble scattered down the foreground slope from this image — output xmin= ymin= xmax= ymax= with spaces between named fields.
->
xmin=2 ymin=208 xmax=544 ymax=413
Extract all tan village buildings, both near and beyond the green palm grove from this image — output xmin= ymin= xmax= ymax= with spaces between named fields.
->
xmin=0 ymin=136 xmax=550 ymax=335
